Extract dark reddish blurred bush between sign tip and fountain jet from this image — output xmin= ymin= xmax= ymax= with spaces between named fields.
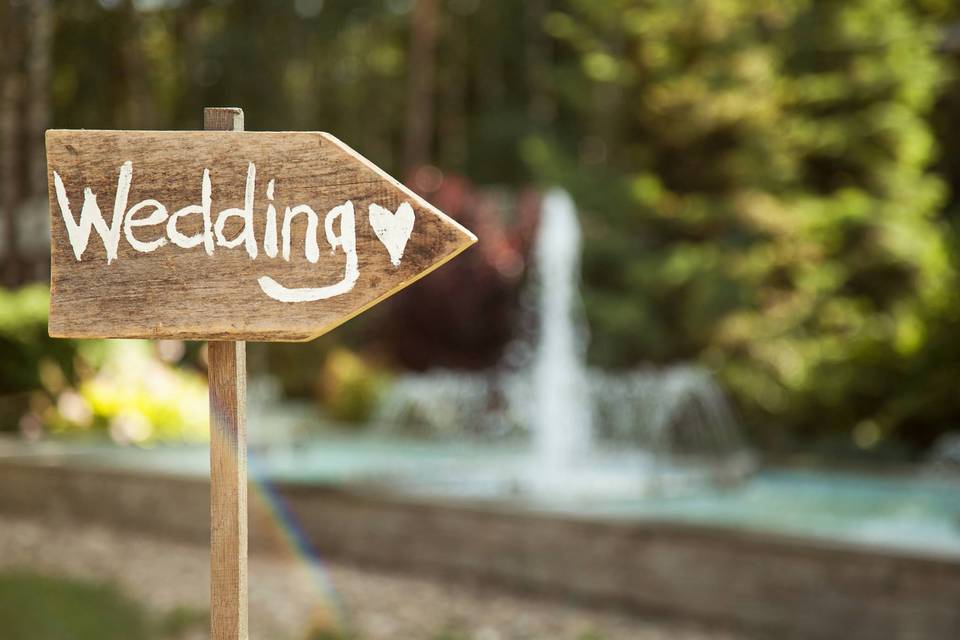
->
xmin=376 ymin=176 xmax=540 ymax=371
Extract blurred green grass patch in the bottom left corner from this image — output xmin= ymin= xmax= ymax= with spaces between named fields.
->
xmin=0 ymin=572 xmax=209 ymax=640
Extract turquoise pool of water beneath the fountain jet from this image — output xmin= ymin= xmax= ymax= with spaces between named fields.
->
xmin=0 ymin=437 xmax=960 ymax=558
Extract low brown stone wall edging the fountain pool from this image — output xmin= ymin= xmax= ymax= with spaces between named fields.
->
xmin=0 ymin=460 xmax=960 ymax=640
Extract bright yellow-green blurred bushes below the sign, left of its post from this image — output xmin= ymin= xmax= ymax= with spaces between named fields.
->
xmin=0 ymin=285 xmax=208 ymax=443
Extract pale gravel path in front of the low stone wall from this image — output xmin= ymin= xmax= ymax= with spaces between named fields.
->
xmin=0 ymin=516 xmax=734 ymax=640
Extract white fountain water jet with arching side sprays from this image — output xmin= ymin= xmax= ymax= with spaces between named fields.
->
xmin=375 ymin=189 xmax=752 ymax=500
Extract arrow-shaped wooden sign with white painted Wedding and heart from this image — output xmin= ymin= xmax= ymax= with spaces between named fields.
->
xmin=46 ymin=130 xmax=476 ymax=341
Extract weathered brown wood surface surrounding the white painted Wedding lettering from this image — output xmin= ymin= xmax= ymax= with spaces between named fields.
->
xmin=47 ymin=129 xmax=476 ymax=341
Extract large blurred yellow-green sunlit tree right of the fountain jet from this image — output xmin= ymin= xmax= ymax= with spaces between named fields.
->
xmin=524 ymin=0 xmax=960 ymax=446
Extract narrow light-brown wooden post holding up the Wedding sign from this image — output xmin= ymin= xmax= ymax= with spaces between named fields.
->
xmin=203 ymin=108 xmax=248 ymax=640
